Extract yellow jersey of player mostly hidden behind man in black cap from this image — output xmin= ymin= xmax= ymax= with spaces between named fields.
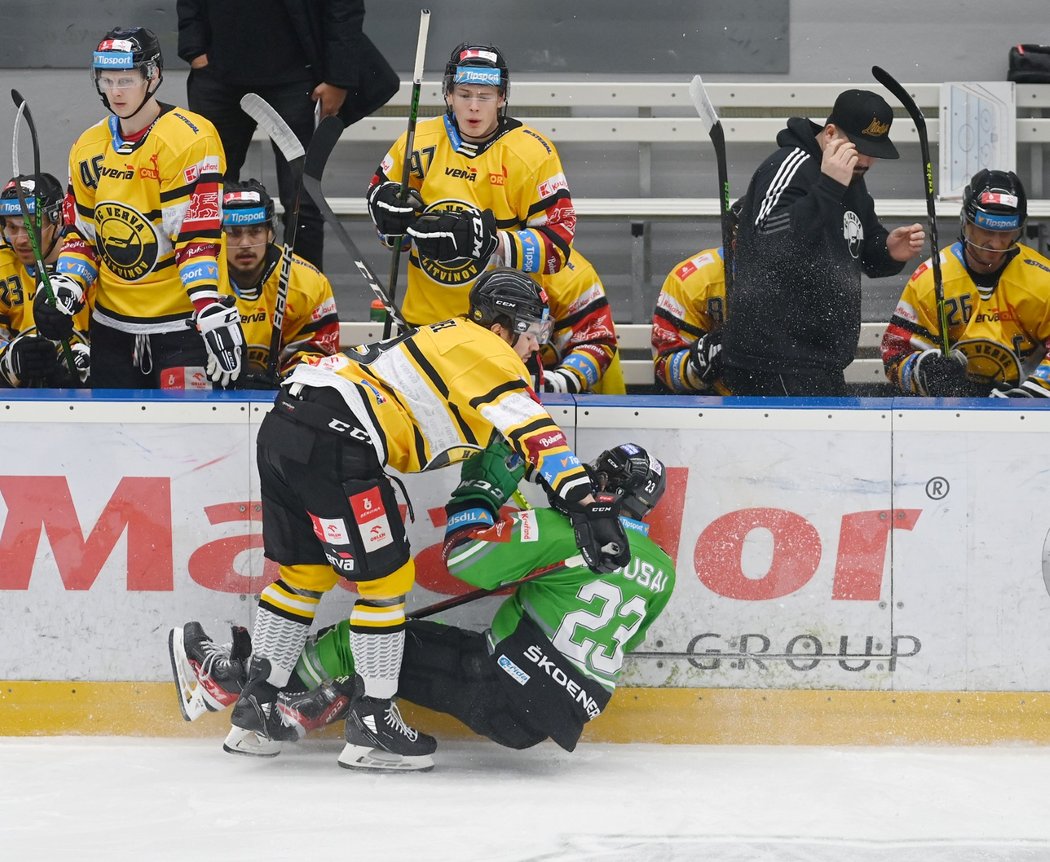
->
xmin=652 ymin=248 xmax=726 ymax=393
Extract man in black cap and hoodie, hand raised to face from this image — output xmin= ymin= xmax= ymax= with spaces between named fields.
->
xmin=721 ymin=90 xmax=926 ymax=396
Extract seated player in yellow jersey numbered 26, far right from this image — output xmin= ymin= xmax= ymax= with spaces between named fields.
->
xmin=882 ymin=170 xmax=1050 ymax=398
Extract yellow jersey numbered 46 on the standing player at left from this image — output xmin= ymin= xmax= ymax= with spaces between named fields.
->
xmin=57 ymin=105 xmax=226 ymax=333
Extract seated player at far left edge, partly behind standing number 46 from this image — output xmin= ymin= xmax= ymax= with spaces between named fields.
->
xmin=0 ymin=173 xmax=90 ymax=388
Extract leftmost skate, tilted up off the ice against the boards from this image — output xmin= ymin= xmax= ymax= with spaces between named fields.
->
xmin=168 ymin=623 xmax=252 ymax=721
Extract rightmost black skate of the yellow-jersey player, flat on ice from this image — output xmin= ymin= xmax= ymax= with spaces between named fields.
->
xmin=339 ymin=676 xmax=438 ymax=772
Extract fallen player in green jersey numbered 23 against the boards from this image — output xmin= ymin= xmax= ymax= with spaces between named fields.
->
xmin=163 ymin=440 xmax=674 ymax=762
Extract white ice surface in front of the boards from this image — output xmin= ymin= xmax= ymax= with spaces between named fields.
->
xmin=0 ymin=737 xmax=1050 ymax=862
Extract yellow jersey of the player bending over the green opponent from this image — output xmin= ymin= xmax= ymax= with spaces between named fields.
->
xmin=286 ymin=317 xmax=590 ymax=500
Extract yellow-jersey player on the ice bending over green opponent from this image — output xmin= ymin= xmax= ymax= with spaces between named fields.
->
xmin=225 ymin=270 xmax=629 ymax=770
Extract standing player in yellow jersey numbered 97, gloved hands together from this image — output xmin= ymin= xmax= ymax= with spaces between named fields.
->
xmin=368 ymin=43 xmax=576 ymax=325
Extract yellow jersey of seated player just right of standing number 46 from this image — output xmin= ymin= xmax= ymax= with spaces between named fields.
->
xmin=223 ymin=246 xmax=339 ymax=374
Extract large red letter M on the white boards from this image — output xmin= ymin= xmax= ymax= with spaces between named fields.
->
xmin=0 ymin=476 xmax=174 ymax=590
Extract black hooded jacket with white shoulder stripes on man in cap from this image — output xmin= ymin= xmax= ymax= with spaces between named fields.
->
xmin=721 ymin=117 xmax=904 ymax=374
